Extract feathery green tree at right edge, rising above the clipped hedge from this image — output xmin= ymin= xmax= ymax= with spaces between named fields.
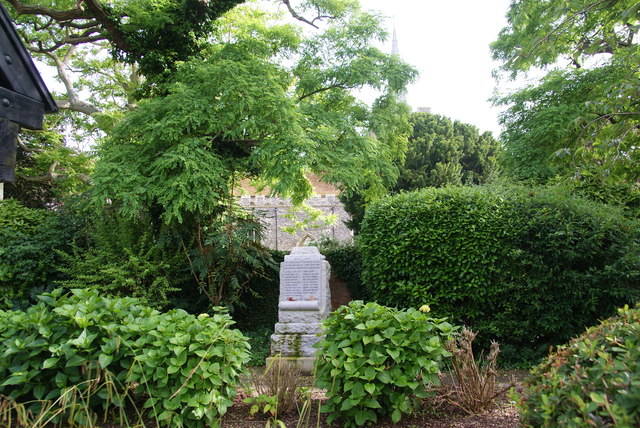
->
xmin=492 ymin=0 xmax=640 ymax=199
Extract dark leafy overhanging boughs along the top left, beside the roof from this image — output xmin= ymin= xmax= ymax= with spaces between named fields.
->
xmin=8 ymin=0 xmax=244 ymax=77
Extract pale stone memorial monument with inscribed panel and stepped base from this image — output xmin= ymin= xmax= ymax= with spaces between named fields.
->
xmin=267 ymin=247 xmax=331 ymax=374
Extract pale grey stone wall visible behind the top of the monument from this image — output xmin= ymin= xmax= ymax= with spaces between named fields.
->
xmin=238 ymin=195 xmax=353 ymax=251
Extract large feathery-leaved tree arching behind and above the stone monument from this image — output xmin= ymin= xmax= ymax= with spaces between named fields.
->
xmin=92 ymin=1 xmax=416 ymax=305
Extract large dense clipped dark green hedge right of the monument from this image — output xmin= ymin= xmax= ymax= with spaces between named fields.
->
xmin=359 ymin=186 xmax=640 ymax=363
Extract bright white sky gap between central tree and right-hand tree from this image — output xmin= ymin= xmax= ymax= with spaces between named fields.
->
xmin=360 ymin=0 xmax=510 ymax=137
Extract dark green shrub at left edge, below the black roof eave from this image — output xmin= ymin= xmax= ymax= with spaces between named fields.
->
xmin=0 ymin=199 xmax=79 ymax=308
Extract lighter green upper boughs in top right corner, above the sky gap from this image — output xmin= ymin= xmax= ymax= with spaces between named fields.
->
xmin=491 ymin=0 xmax=640 ymax=74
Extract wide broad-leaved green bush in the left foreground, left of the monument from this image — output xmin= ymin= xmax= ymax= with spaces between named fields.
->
xmin=0 ymin=289 xmax=249 ymax=427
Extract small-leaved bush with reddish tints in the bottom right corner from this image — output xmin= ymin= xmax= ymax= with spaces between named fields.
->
xmin=516 ymin=306 xmax=640 ymax=427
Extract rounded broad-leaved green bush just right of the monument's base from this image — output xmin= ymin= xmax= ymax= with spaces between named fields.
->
xmin=316 ymin=301 xmax=455 ymax=426
